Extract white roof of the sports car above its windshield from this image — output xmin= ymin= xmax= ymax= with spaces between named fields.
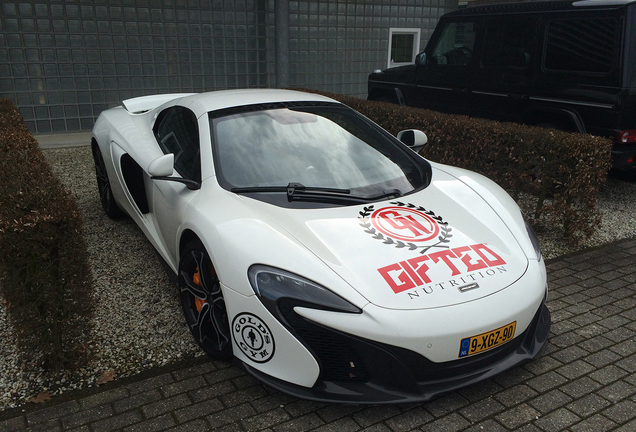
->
xmin=178 ymin=89 xmax=338 ymax=118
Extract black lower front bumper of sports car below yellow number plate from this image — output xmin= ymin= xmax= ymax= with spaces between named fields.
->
xmin=242 ymin=300 xmax=550 ymax=404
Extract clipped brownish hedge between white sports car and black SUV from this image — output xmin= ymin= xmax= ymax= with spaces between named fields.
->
xmin=310 ymin=90 xmax=612 ymax=244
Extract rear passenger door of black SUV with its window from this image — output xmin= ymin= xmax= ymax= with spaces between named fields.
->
xmin=470 ymin=16 xmax=540 ymax=121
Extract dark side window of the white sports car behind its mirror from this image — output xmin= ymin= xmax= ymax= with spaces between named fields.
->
xmin=154 ymin=106 xmax=201 ymax=181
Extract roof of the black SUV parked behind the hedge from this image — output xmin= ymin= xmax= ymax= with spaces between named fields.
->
xmin=444 ymin=0 xmax=636 ymax=17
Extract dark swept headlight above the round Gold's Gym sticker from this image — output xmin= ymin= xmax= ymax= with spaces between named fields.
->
xmin=248 ymin=265 xmax=362 ymax=319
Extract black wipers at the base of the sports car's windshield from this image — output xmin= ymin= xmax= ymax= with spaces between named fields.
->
xmin=230 ymin=182 xmax=402 ymax=204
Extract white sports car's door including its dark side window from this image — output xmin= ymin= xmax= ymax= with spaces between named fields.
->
xmin=151 ymin=106 xmax=201 ymax=259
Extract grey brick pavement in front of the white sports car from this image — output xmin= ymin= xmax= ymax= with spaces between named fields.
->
xmin=0 ymin=238 xmax=636 ymax=432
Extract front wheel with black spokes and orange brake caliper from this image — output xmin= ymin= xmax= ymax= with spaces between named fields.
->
xmin=178 ymin=240 xmax=232 ymax=360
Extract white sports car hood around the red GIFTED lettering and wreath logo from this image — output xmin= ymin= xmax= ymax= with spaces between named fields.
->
xmin=238 ymin=172 xmax=528 ymax=309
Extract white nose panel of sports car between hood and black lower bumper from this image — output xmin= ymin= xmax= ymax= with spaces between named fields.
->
xmin=295 ymin=263 xmax=546 ymax=362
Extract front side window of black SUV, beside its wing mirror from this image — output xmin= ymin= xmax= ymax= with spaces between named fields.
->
xmin=429 ymin=21 xmax=476 ymax=66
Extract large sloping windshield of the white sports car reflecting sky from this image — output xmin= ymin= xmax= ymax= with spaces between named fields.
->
xmin=210 ymin=104 xmax=427 ymax=200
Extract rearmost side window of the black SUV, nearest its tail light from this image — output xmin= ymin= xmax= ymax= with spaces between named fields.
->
xmin=544 ymin=18 xmax=618 ymax=74
